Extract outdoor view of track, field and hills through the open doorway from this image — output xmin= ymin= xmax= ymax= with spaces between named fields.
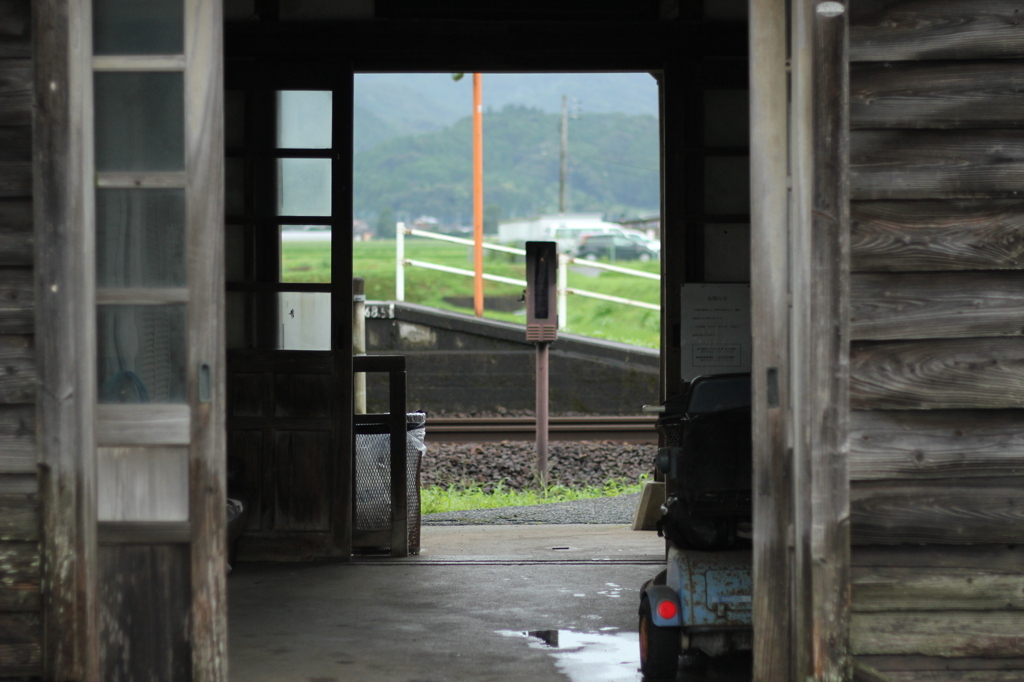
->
xmin=353 ymin=73 xmax=662 ymax=520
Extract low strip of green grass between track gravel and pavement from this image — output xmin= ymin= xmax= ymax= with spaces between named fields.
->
xmin=420 ymin=480 xmax=644 ymax=514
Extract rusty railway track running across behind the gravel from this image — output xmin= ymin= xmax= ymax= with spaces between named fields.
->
xmin=427 ymin=416 xmax=657 ymax=443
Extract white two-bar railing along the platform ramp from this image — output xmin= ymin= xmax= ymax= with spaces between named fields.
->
xmin=394 ymin=222 xmax=662 ymax=329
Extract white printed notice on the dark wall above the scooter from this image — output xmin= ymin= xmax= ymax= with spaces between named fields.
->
xmin=680 ymin=284 xmax=752 ymax=381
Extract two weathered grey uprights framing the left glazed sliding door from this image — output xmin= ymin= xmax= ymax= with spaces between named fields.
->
xmin=32 ymin=0 xmax=227 ymax=681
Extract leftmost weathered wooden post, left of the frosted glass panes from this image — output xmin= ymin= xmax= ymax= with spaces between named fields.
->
xmin=32 ymin=0 xmax=99 ymax=680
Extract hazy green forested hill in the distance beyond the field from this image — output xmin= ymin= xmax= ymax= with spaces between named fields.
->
xmin=353 ymin=105 xmax=659 ymax=224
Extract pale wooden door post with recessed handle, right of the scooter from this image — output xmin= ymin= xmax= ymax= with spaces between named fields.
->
xmin=750 ymin=0 xmax=796 ymax=682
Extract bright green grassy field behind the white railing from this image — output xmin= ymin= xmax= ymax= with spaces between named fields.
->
xmin=283 ymin=238 xmax=660 ymax=348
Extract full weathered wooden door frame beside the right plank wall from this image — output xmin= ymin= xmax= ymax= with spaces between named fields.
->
xmin=750 ymin=0 xmax=852 ymax=682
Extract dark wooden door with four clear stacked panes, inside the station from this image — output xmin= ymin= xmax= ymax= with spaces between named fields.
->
xmin=225 ymin=71 xmax=352 ymax=561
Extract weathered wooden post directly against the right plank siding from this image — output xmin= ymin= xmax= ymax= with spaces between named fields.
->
xmin=790 ymin=0 xmax=852 ymax=682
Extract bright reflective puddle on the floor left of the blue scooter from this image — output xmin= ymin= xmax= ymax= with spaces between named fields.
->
xmin=496 ymin=628 xmax=643 ymax=682
